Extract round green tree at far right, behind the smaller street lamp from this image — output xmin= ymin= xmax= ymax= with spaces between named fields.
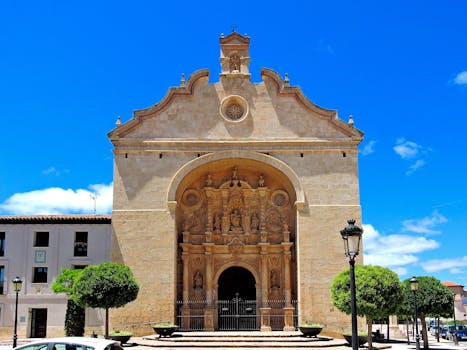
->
xmin=399 ymin=276 xmax=452 ymax=349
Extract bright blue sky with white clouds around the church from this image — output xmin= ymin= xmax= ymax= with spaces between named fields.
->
xmin=0 ymin=0 xmax=467 ymax=285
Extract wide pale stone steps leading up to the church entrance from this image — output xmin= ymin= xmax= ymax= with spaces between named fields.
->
xmin=131 ymin=332 xmax=348 ymax=350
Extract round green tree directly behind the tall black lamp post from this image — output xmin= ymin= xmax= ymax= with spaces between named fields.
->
xmin=331 ymin=265 xmax=402 ymax=349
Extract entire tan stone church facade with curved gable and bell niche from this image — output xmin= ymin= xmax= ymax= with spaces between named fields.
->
xmin=108 ymin=32 xmax=363 ymax=334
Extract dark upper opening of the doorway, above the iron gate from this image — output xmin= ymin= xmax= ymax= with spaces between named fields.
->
xmin=217 ymin=266 xmax=256 ymax=300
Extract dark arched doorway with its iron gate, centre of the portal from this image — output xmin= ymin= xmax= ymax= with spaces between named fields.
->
xmin=217 ymin=266 xmax=257 ymax=331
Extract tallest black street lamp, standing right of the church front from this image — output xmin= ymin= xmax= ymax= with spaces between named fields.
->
xmin=341 ymin=220 xmax=363 ymax=350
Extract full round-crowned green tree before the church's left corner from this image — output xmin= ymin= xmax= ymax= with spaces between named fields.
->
xmin=72 ymin=262 xmax=139 ymax=338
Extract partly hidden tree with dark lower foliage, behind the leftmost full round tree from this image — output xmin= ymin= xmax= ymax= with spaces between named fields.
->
xmin=51 ymin=269 xmax=85 ymax=337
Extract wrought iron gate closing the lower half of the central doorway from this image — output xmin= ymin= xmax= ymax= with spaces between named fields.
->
xmin=217 ymin=293 xmax=258 ymax=331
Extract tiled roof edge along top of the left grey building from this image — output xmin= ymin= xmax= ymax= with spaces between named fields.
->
xmin=0 ymin=214 xmax=112 ymax=224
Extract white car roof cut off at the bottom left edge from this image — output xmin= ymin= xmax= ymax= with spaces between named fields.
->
xmin=15 ymin=337 xmax=122 ymax=350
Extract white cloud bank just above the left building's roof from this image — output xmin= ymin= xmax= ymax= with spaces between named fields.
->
xmin=0 ymin=183 xmax=113 ymax=215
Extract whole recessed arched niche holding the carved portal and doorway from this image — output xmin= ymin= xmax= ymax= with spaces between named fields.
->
xmin=175 ymin=158 xmax=297 ymax=331
